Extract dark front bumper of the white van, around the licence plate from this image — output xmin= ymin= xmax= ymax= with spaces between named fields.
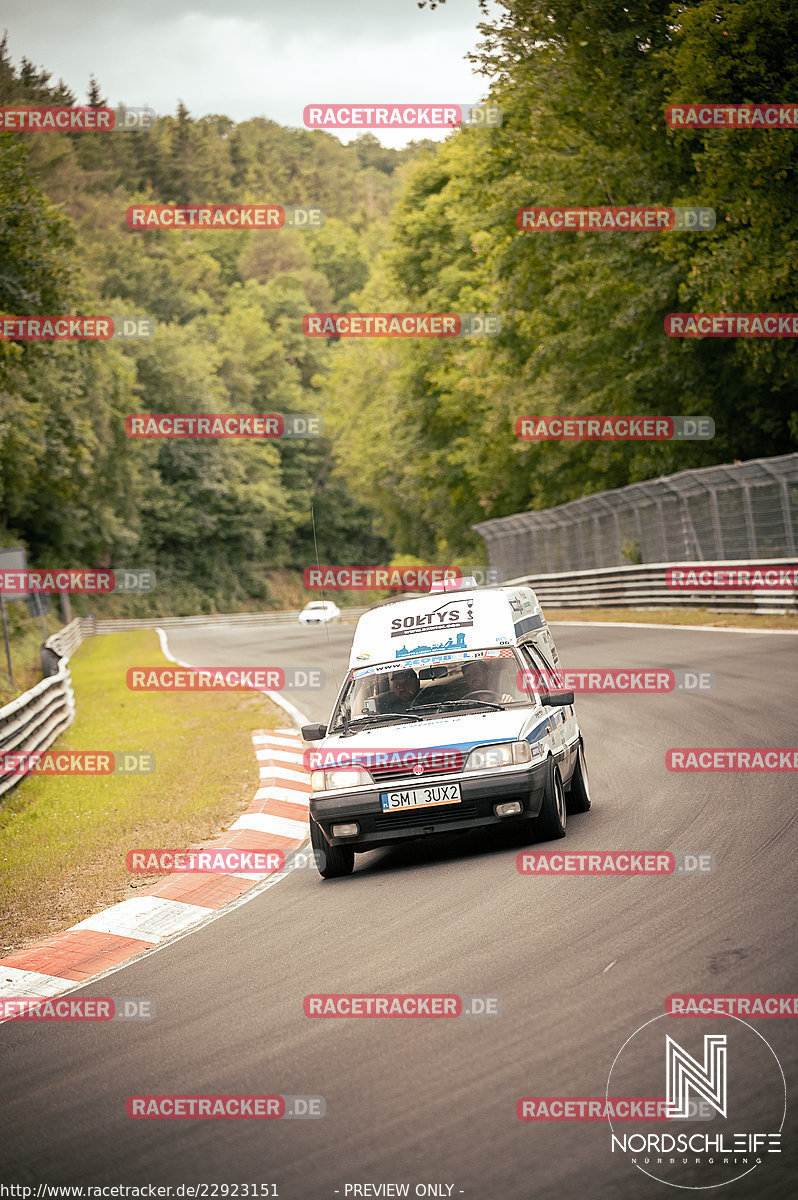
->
xmin=310 ymin=758 xmax=551 ymax=851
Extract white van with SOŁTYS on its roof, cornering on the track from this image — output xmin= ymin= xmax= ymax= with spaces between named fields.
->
xmin=302 ymin=580 xmax=590 ymax=878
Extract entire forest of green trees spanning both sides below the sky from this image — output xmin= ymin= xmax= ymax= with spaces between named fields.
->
xmin=0 ymin=0 xmax=798 ymax=600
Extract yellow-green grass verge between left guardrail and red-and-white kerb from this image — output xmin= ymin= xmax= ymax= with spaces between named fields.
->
xmin=0 ymin=629 xmax=279 ymax=954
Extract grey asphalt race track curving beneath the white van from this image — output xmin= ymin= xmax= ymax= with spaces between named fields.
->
xmin=0 ymin=625 xmax=798 ymax=1200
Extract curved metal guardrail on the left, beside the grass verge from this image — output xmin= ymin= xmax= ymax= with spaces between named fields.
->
xmin=0 ymin=620 xmax=83 ymax=796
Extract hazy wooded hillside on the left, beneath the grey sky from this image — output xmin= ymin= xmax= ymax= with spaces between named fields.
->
xmin=0 ymin=41 xmax=415 ymax=611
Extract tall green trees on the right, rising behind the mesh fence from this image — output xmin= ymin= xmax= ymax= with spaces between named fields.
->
xmin=325 ymin=0 xmax=798 ymax=559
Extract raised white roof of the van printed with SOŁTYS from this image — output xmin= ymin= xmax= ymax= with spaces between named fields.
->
xmin=349 ymin=587 xmax=546 ymax=667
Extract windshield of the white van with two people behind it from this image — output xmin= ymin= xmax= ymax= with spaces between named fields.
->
xmin=329 ymin=647 xmax=532 ymax=733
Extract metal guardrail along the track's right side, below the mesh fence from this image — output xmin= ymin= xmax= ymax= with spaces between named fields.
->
xmin=505 ymin=558 xmax=798 ymax=613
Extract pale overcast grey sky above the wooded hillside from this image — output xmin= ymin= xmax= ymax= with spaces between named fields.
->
xmin=0 ymin=0 xmax=499 ymax=146
